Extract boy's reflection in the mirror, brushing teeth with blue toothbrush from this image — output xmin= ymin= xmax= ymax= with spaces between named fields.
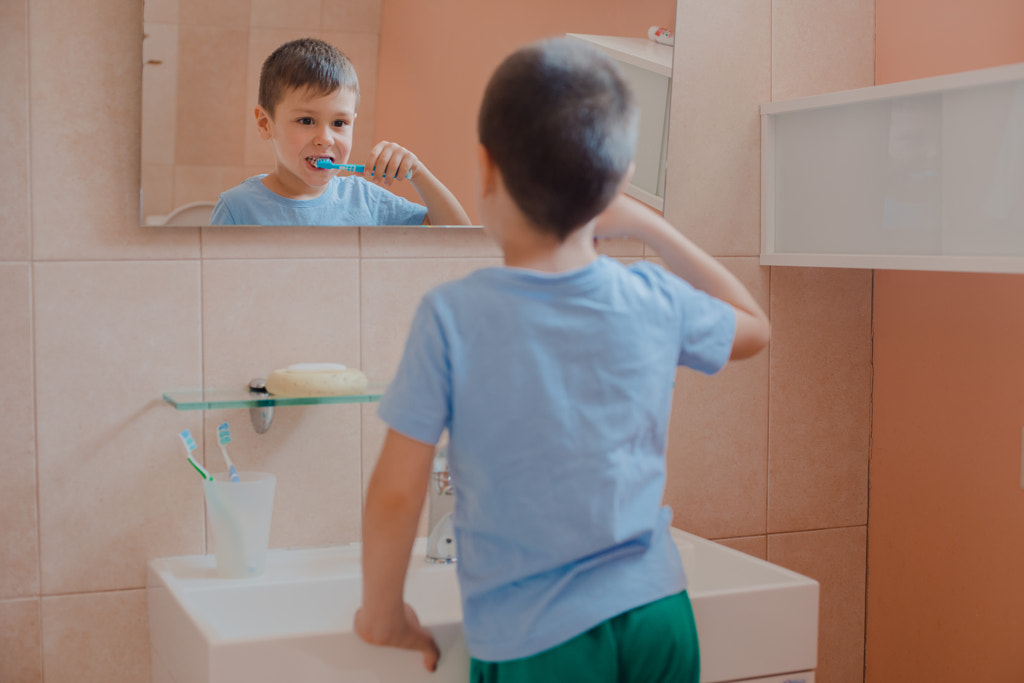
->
xmin=216 ymin=38 xmax=469 ymax=225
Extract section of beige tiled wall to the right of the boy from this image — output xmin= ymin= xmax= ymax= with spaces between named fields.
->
xmin=666 ymin=0 xmax=874 ymax=683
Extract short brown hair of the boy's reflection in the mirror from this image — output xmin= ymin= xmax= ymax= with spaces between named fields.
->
xmin=258 ymin=38 xmax=359 ymax=117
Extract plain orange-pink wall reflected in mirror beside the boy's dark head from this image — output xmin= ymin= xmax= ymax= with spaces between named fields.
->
xmin=376 ymin=0 xmax=676 ymax=219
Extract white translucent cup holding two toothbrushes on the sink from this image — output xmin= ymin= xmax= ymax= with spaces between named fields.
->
xmin=203 ymin=472 xmax=278 ymax=579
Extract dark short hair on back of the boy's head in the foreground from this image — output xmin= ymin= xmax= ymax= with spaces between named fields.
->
xmin=477 ymin=38 xmax=639 ymax=241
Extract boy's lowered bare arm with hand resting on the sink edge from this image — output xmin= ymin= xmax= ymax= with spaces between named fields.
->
xmin=354 ymin=429 xmax=440 ymax=671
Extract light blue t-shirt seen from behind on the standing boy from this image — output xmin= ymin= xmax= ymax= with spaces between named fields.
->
xmin=379 ymin=256 xmax=735 ymax=661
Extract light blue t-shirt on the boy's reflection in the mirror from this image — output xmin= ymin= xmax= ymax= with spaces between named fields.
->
xmin=210 ymin=174 xmax=427 ymax=225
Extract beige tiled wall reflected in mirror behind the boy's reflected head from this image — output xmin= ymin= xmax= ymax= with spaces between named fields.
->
xmin=142 ymin=0 xmax=381 ymax=222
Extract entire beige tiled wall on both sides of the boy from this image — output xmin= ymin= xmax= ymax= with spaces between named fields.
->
xmin=0 ymin=0 xmax=872 ymax=683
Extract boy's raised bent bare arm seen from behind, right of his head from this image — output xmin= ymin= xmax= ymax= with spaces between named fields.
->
xmin=594 ymin=194 xmax=770 ymax=360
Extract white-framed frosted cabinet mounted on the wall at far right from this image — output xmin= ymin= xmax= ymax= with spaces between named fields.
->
xmin=761 ymin=63 xmax=1024 ymax=272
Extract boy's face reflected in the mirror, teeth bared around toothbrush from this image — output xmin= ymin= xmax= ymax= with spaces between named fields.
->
xmin=256 ymin=88 xmax=356 ymax=199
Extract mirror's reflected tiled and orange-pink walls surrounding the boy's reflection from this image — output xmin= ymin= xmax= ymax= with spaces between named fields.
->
xmin=140 ymin=0 xmax=676 ymax=225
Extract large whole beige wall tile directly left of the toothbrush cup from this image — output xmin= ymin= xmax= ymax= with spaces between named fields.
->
xmin=34 ymin=261 xmax=203 ymax=595
